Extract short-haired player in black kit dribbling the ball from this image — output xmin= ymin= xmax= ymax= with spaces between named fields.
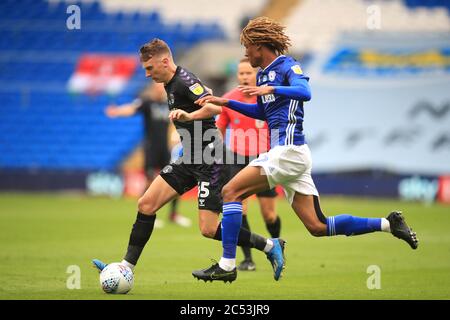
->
xmin=93 ymin=39 xmax=283 ymax=282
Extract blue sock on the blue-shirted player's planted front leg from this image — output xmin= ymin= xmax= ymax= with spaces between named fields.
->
xmin=222 ymin=202 xmax=242 ymax=259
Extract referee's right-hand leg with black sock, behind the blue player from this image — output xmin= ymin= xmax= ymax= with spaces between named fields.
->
xmin=256 ymin=189 xmax=281 ymax=238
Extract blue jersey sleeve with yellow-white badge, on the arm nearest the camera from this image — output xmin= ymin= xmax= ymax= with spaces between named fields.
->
xmin=274 ymin=64 xmax=311 ymax=101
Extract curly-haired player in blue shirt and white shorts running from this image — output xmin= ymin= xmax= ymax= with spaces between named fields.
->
xmin=193 ymin=17 xmax=418 ymax=281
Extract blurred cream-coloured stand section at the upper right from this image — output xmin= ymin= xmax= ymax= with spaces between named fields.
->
xmin=284 ymin=0 xmax=450 ymax=52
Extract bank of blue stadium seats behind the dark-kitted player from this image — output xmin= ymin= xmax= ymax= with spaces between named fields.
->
xmin=0 ymin=0 xmax=225 ymax=170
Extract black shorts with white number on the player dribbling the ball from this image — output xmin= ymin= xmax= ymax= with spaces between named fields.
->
xmin=160 ymin=160 xmax=224 ymax=212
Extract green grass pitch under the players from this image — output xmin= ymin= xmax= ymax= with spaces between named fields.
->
xmin=0 ymin=193 xmax=450 ymax=300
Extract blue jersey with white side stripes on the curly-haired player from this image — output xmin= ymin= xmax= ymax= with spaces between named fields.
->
xmin=256 ymin=55 xmax=309 ymax=148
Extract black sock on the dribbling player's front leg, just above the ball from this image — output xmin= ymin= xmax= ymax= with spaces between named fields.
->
xmin=123 ymin=212 xmax=156 ymax=266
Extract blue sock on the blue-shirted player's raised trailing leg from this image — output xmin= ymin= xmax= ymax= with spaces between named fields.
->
xmin=327 ymin=214 xmax=381 ymax=236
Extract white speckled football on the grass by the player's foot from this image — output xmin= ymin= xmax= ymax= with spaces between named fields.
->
xmin=100 ymin=262 xmax=134 ymax=294
